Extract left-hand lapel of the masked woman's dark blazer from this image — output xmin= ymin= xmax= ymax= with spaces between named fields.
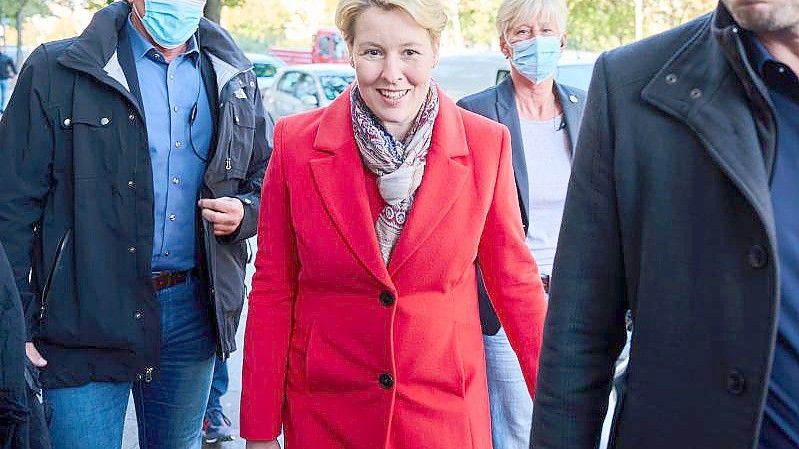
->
xmin=497 ymin=77 xmax=530 ymax=228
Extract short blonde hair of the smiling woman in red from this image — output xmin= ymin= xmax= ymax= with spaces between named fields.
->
xmin=336 ymin=0 xmax=447 ymax=46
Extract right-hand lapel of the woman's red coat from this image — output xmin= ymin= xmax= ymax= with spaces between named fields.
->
xmin=388 ymin=90 xmax=471 ymax=275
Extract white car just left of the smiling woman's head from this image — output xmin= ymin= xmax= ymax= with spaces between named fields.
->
xmin=265 ymin=64 xmax=355 ymax=120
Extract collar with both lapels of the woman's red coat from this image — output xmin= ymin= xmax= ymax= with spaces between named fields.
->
xmin=310 ymin=88 xmax=471 ymax=287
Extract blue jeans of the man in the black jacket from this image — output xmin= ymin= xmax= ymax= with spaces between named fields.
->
xmin=45 ymin=272 xmax=216 ymax=449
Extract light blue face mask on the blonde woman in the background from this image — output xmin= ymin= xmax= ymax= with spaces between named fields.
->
xmin=511 ymin=36 xmax=560 ymax=83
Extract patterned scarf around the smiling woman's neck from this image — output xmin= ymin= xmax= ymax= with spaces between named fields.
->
xmin=350 ymin=83 xmax=438 ymax=265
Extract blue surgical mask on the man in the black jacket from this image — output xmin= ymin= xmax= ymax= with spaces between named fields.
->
xmin=133 ymin=0 xmax=205 ymax=49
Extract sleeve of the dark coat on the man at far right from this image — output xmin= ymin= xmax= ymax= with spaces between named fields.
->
xmin=532 ymin=54 xmax=627 ymax=449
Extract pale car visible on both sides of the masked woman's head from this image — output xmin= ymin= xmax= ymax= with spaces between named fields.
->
xmin=433 ymin=50 xmax=598 ymax=100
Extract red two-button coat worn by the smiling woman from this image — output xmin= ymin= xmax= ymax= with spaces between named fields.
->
xmin=241 ymin=86 xmax=546 ymax=449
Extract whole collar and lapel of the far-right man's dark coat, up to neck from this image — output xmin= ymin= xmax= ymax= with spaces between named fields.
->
xmin=641 ymin=3 xmax=775 ymax=242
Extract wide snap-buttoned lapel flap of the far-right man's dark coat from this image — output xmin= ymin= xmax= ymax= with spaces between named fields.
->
xmin=641 ymin=20 xmax=776 ymax=242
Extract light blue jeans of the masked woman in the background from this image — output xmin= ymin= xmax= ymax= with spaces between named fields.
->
xmin=483 ymin=328 xmax=533 ymax=449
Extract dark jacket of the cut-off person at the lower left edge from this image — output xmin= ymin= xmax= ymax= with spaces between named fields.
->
xmin=0 ymin=244 xmax=50 ymax=449
